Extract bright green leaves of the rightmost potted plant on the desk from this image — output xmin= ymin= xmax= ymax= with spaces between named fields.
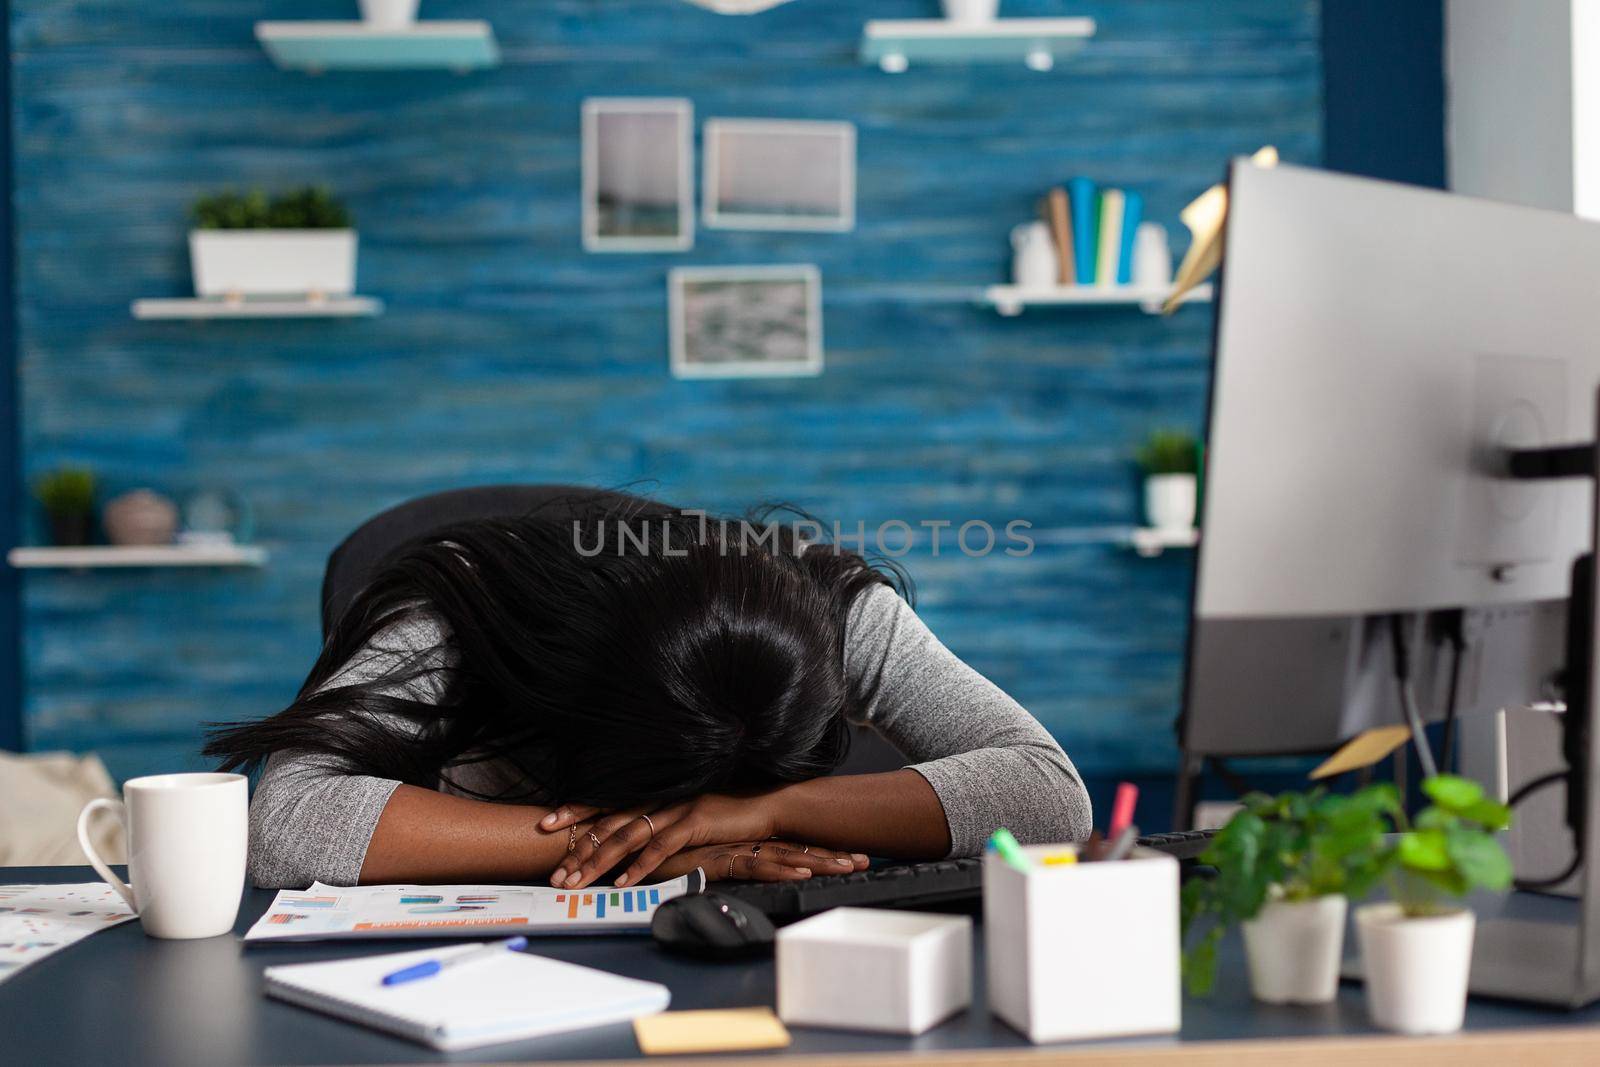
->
xmin=1390 ymin=774 xmax=1514 ymax=918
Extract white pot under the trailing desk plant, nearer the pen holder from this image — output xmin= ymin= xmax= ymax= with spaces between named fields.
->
xmin=1243 ymin=896 xmax=1346 ymax=1005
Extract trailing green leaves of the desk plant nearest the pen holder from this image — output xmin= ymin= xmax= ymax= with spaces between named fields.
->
xmin=1181 ymin=784 xmax=1400 ymax=995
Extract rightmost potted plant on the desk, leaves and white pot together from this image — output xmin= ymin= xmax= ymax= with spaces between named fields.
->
xmin=1355 ymin=774 xmax=1512 ymax=1033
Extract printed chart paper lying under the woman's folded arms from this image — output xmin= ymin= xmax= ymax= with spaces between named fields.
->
xmin=245 ymin=870 xmax=706 ymax=941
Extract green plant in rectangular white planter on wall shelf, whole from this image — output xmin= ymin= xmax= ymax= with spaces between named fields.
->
xmin=189 ymin=187 xmax=357 ymax=301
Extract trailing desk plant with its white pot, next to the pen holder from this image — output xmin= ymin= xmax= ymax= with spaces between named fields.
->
xmin=1182 ymin=785 xmax=1398 ymax=1005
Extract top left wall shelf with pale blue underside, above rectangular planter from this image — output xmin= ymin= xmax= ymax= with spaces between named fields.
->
xmin=256 ymin=19 xmax=499 ymax=74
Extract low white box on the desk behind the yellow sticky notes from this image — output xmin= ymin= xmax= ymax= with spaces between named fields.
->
xmin=778 ymin=907 xmax=973 ymax=1033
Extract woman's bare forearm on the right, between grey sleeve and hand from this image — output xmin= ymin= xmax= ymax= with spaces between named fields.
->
xmin=768 ymin=768 xmax=950 ymax=859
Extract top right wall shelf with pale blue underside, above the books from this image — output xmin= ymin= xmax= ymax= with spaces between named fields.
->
xmin=861 ymin=18 xmax=1094 ymax=74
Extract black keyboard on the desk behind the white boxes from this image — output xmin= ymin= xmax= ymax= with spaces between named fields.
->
xmin=720 ymin=830 xmax=1216 ymax=923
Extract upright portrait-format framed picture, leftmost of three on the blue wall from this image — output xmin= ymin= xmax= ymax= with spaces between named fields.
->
xmin=582 ymin=96 xmax=694 ymax=251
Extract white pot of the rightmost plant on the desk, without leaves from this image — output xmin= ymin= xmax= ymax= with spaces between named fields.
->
xmin=1355 ymin=904 xmax=1477 ymax=1033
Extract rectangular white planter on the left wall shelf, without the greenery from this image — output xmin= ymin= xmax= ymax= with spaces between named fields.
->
xmin=189 ymin=230 xmax=357 ymax=296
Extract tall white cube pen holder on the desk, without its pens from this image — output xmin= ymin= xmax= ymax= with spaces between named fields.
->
xmin=984 ymin=845 xmax=1182 ymax=1043
